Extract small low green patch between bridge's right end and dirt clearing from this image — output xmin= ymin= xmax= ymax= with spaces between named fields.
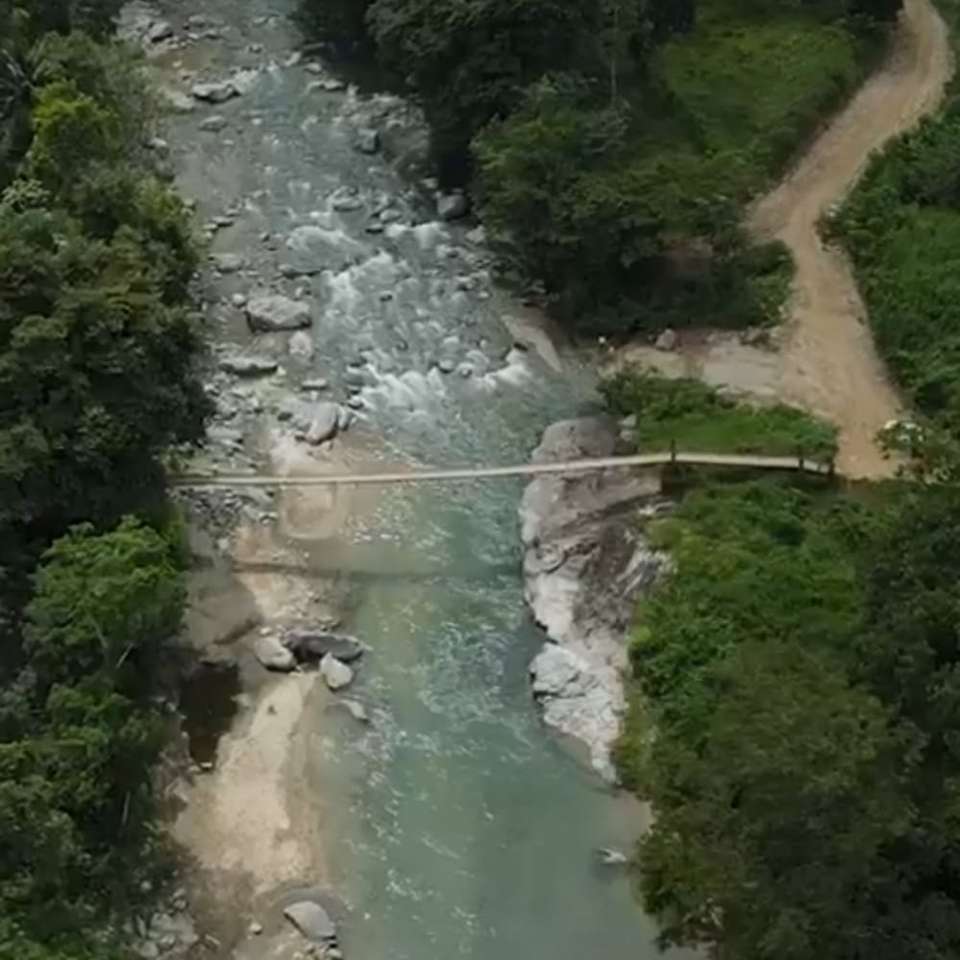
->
xmin=601 ymin=370 xmax=837 ymax=461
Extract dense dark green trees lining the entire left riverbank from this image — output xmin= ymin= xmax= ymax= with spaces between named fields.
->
xmin=0 ymin=0 xmax=206 ymax=960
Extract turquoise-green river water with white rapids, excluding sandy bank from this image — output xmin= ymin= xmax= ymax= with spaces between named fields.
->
xmin=150 ymin=0 xmax=688 ymax=960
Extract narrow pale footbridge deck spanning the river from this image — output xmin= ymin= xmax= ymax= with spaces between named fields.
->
xmin=172 ymin=451 xmax=833 ymax=488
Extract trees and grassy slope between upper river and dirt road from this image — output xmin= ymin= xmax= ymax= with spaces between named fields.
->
xmin=301 ymin=0 xmax=899 ymax=330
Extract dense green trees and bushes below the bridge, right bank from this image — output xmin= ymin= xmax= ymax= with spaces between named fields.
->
xmin=618 ymin=482 xmax=960 ymax=960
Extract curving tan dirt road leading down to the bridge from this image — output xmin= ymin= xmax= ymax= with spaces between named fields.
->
xmin=749 ymin=0 xmax=953 ymax=477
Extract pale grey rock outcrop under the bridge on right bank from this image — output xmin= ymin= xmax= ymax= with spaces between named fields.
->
xmin=520 ymin=418 xmax=669 ymax=782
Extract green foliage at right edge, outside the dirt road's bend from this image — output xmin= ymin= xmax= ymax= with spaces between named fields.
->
xmin=828 ymin=90 xmax=960 ymax=434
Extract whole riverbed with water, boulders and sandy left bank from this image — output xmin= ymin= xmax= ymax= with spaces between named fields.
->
xmin=114 ymin=0 xmax=684 ymax=960
